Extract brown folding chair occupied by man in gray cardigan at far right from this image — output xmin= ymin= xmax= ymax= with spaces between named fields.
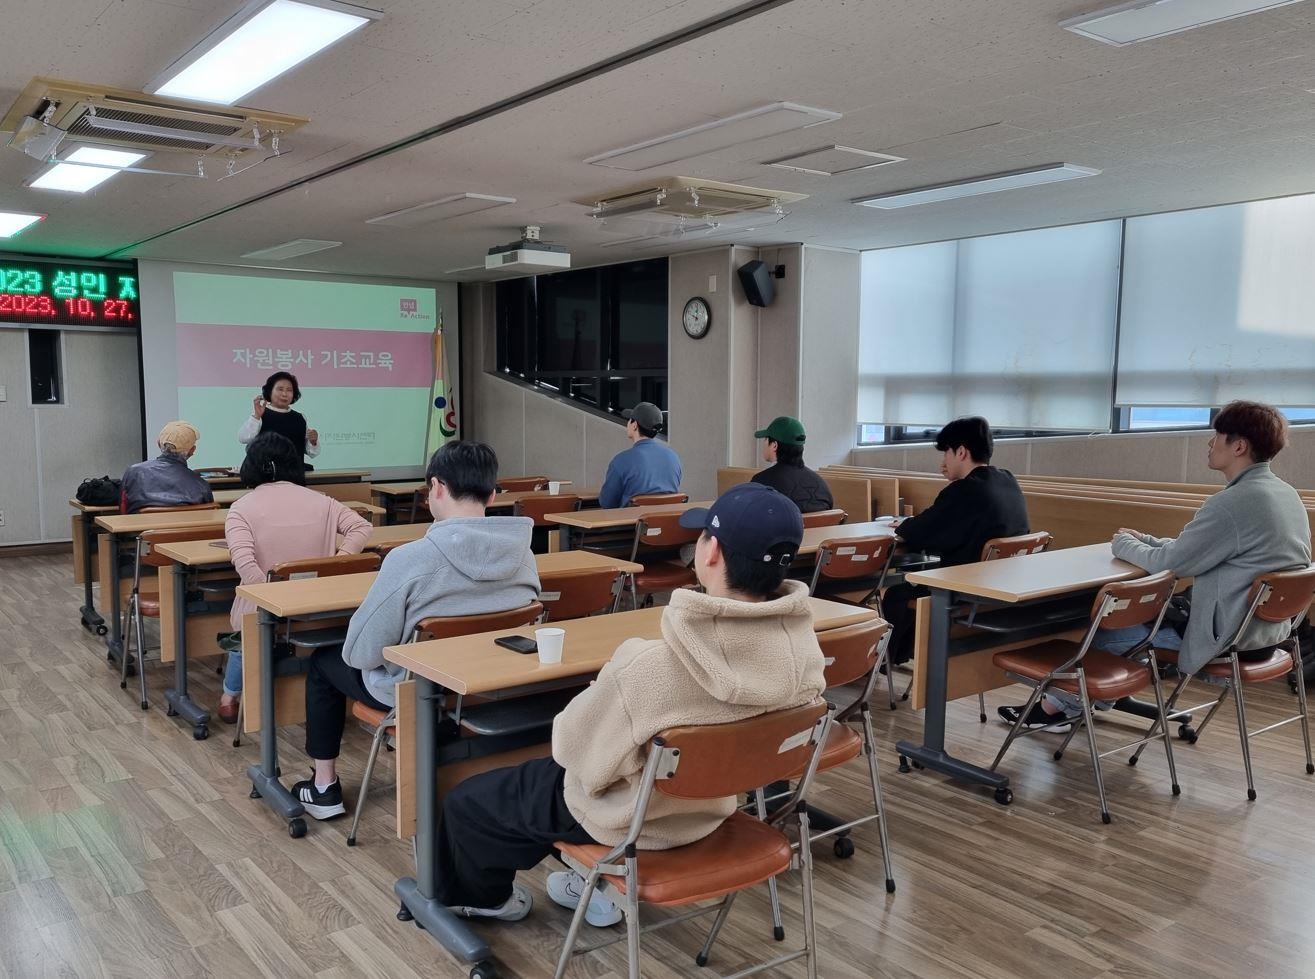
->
xmin=1128 ymin=565 xmax=1315 ymax=801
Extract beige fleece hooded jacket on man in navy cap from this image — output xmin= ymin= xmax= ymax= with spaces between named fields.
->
xmin=552 ymin=582 xmax=826 ymax=850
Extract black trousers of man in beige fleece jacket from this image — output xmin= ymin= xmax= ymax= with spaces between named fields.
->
xmin=435 ymin=758 xmax=594 ymax=908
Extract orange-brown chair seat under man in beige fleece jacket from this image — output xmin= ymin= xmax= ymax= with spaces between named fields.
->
xmin=556 ymin=812 xmax=792 ymax=904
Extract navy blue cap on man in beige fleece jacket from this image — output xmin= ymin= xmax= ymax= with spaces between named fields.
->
xmin=680 ymin=483 xmax=803 ymax=566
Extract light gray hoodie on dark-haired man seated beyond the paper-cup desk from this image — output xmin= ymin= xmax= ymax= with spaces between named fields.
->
xmin=342 ymin=517 xmax=539 ymax=707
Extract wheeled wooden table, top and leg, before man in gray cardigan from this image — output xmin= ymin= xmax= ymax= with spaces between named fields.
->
xmin=896 ymin=543 xmax=1145 ymax=805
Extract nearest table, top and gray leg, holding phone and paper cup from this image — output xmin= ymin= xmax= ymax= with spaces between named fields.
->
xmin=384 ymin=599 xmax=877 ymax=966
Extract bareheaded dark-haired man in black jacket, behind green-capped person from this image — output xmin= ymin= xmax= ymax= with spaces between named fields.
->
xmin=881 ymin=417 xmax=1028 ymax=663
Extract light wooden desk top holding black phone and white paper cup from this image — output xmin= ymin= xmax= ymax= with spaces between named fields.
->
xmin=384 ymin=599 xmax=877 ymax=693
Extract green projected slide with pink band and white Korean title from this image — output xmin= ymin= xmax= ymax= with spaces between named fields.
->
xmin=174 ymin=271 xmax=447 ymax=470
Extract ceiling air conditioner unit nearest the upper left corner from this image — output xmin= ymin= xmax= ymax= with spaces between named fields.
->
xmin=0 ymin=78 xmax=308 ymax=162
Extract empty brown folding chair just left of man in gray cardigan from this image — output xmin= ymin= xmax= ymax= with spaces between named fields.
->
xmin=990 ymin=571 xmax=1181 ymax=822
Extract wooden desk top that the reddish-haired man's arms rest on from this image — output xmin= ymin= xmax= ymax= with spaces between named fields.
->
xmin=905 ymin=543 xmax=1145 ymax=603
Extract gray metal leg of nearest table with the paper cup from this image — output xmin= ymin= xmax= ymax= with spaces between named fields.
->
xmin=393 ymin=676 xmax=493 ymax=965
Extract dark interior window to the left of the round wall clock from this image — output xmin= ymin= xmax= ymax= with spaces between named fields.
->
xmin=496 ymin=258 xmax=667 ymax=413
